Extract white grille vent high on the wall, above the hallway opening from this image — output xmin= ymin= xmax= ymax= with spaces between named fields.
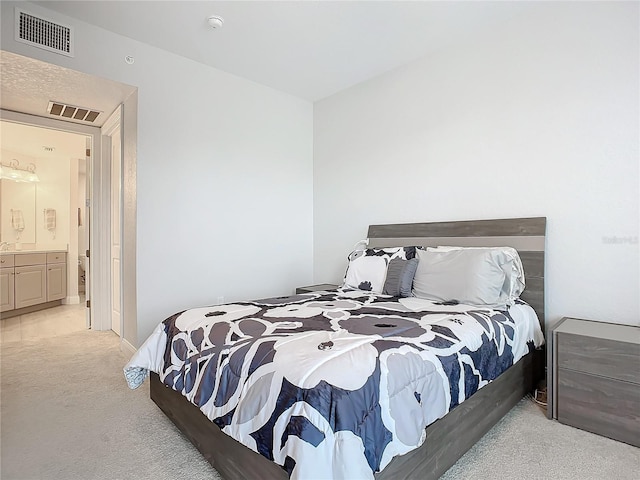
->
xmin=15 ymin=8 xmax=73 ymax=57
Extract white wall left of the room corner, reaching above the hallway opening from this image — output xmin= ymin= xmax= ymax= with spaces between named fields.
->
xmin=1 ymin=2 xmax=313 ymax=344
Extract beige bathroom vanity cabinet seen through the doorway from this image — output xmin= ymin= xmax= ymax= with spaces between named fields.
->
xmin=0 ymin=250 xmax=67 ymax=318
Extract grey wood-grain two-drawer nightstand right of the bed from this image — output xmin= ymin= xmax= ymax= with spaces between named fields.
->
xmin=548 ymin=318 xmax=640 ymax=446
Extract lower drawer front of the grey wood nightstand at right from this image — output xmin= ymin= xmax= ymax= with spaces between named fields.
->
xmin=558 ymin=369 xmax=640 ymax=447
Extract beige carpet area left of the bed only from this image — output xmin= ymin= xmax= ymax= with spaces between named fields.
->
xmin=0 ymin=331 xmax=220 ymax=480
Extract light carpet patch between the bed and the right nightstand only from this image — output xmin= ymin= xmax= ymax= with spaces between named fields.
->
xmin=441 ymin=399 xmax=640 ymax=480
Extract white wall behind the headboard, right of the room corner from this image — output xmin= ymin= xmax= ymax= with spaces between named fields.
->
xmin=314 ymin=2 xmax=640 ymax=324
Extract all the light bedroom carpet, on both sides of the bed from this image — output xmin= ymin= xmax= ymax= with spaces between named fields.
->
xmin=0 ymin=331 xmax=640 ymax=480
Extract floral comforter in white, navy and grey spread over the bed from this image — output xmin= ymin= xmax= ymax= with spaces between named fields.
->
xmin=125 ymin=289 xmax=544 ymax=479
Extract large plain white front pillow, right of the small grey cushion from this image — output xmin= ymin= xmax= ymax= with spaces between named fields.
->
xmin=413 ymin=249 xmax=513 ymax=308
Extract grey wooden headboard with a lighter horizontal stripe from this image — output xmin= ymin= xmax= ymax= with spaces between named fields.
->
xmin=368 ymin=217 xmax=547 ymax=332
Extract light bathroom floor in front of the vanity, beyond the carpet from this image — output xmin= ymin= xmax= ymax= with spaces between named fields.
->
xmin=0 ymin=297 xmax=87 ymax=344
